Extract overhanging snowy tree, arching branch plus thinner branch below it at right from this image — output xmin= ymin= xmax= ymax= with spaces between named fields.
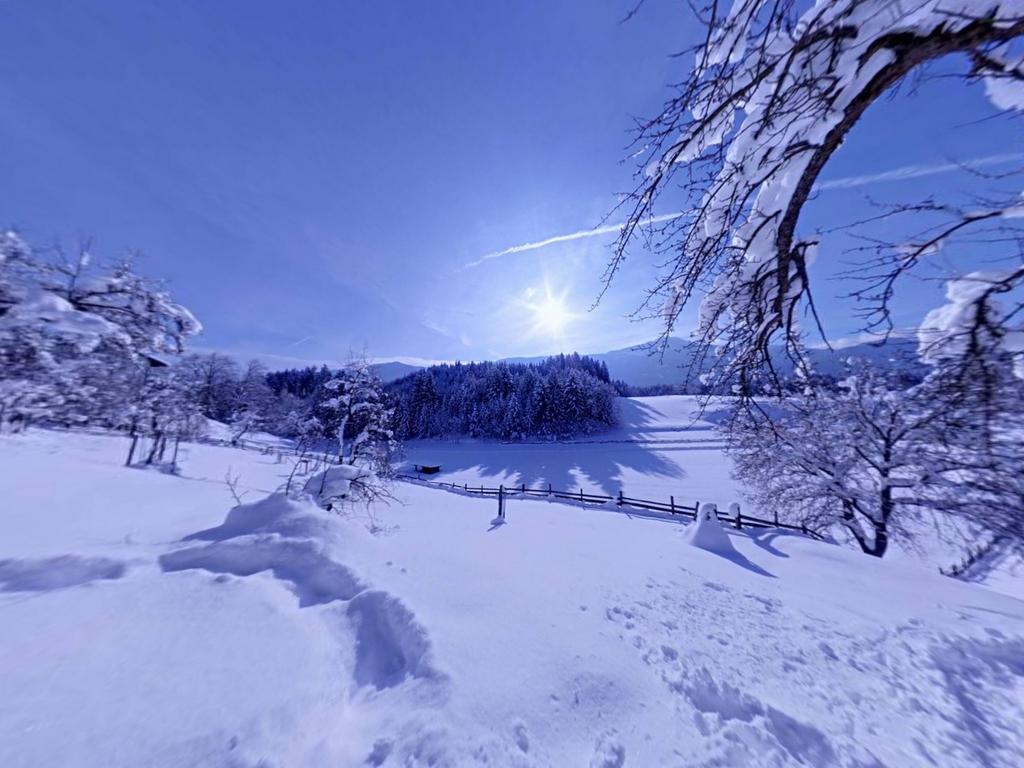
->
xmin=605 ymin=0 xmax=1024 ymax=393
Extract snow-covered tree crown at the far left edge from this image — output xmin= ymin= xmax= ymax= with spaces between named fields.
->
xmin=0 ymin=232 xmax=201 ymax=434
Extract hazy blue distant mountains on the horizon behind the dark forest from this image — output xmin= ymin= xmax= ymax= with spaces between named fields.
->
xmin=374 ymin=338 xmax=924 ymax=387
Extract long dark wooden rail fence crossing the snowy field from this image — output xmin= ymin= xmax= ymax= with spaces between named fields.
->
xmin=395 ymin=474 xmax=821 ymax=539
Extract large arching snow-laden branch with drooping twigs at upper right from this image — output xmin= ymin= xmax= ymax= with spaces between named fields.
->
xmin=616 ymin=0 xmax=1024 ymax=391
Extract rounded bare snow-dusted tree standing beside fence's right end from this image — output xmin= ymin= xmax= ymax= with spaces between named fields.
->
xmin=729 ymin=370 xmax=944 ymax=557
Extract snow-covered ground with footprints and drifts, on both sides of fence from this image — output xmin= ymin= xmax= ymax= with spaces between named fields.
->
xmin=0 ymin=398 xmax=1024 ymax=768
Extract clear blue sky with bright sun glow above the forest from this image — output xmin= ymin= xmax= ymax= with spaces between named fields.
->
xmin=0 ymin=0 xmax=1024 ymax=360
